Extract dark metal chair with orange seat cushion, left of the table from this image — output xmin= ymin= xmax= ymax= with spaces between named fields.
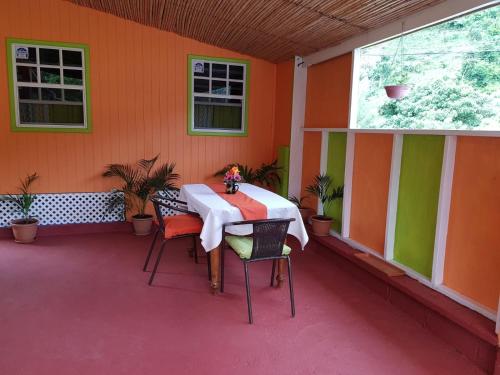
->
xmin=142 ymin=195 xmax=211 ymax=285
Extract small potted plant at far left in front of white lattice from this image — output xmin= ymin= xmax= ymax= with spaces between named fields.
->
xmin=0 ymin=173 xmax=39 ymax=243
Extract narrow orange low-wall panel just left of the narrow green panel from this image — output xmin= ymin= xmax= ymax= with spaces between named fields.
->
xmin=301 ymin=132 xmax=321 ymax=210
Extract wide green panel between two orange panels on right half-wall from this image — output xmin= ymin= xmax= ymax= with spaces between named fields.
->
xmin=394 ymin=135 xmax=444 ymax=278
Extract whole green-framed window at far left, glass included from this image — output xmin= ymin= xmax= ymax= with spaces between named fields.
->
xmin=6 ymin=38 xmax=92 ymax=133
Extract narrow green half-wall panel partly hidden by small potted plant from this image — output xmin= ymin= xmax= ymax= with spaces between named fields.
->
xmin=326 ymin=133 xmax=347 ymax=233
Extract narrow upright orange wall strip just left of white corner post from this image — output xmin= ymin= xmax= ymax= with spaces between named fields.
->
xmin=274 ymin=60 xmax=294 ymax=151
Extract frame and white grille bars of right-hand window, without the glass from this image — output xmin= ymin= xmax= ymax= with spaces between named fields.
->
xmin=188 ymin=56 xmax=249 ymax=136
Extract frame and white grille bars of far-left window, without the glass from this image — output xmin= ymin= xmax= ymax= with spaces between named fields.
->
xmin=10 ymin=41 xmax=89 ymax=131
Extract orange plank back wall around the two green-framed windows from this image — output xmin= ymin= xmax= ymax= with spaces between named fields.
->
xmin=0 ymin=0 xmax=281 ymax=193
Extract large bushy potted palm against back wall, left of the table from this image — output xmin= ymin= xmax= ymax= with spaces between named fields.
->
xmin=102 ymin=155 xmax=179 ymax=236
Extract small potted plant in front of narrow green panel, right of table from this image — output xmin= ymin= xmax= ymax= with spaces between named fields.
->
xmin=306 ymin=174 xmax=344 ymax=236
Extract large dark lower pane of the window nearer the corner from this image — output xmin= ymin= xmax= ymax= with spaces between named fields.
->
xmin=194 ymin=97 xmax=242 ymax=130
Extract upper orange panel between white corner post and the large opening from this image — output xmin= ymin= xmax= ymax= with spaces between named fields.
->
xmin=305 ymin=53 xmax=352 ymax=128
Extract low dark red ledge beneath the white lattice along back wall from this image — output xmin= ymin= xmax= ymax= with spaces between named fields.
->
xmin=0 ymin=221 xmax=133 ymax=239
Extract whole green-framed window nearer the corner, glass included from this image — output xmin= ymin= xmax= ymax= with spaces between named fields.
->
xmin=187 ymin=55 xmax=250 ymax=137
